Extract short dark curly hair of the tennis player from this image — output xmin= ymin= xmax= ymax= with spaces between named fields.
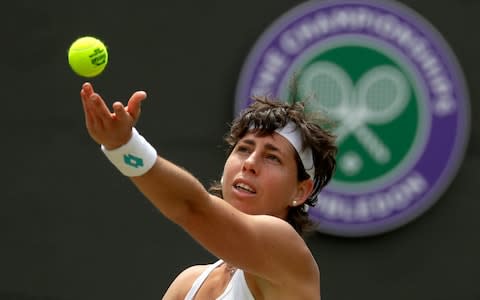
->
xmin=209 ymin=97 xmax=337 ymax=236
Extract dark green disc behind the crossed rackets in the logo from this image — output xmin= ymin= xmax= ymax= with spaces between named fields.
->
xmin=299 ymin=44 xmax=420 ymax=185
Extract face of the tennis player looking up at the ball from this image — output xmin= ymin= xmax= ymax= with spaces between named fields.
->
xmin=222 ymin=133 xmax=304 ymax=219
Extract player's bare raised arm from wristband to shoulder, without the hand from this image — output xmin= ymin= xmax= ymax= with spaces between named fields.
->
xmin=132 ymin=158 xmax=318 ymax=284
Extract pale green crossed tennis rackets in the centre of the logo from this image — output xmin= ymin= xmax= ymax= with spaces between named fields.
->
xmin=298 ymin=62 xmax=408 ymax=164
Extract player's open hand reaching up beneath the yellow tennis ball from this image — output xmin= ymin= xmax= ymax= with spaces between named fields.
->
xmin=80 ymin=82 xmax=147 ymax=150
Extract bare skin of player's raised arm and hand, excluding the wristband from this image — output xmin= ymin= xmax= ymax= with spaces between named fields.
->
xmin=81 ymin=83 xmax=318 ymax=286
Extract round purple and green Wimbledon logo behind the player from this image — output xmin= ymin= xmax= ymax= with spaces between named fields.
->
xmin=235 ymin=1 xmax=469 ymax=236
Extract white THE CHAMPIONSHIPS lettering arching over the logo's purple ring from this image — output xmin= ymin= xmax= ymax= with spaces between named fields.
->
xmin=262 ymin=7 xmax=457 ymax=116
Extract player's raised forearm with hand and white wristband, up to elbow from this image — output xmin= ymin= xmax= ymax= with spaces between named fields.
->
xmin=80 ymin=83 xmax=210 ymax=223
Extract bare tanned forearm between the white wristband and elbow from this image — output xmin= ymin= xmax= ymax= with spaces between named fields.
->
xmin=131 ymin=157 xmax=210 ymax=223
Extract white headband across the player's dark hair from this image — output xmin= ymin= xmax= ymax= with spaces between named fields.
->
xmin=275 ymin=122 xmax=315 ymax=179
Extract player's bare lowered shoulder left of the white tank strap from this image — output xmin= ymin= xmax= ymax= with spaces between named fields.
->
xmin=162 ymin=265 xmax=208 ymax=300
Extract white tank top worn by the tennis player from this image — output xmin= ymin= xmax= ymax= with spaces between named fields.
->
xmin=185 ymin=260 xmax=255 ymax=300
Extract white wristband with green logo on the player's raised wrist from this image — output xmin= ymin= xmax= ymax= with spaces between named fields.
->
xmin=101 ymin=128 xmax=157 ymax=177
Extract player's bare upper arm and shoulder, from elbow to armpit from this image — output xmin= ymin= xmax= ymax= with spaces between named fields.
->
xmin=174 ymin=196 xmax=316 ymax=283
